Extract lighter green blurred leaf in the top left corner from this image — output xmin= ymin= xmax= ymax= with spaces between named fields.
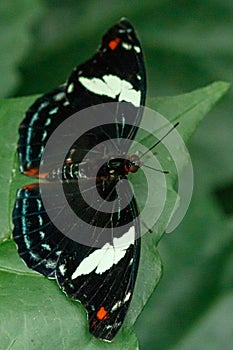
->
xmin=0 ymin=0 xmax=43 ymax=97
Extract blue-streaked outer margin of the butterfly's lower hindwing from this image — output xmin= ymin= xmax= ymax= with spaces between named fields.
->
xmin=13 ymin=184 xmax=68 ymax=278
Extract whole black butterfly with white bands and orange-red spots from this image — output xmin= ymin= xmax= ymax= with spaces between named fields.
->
xmin=13 ymin=19 xmax=146 ymax=341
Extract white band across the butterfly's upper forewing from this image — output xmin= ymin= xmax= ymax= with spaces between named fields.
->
xmin=78 ymin=74 xmax=141 ymax=107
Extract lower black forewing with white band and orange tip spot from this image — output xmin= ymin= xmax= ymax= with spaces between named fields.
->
xmin=56 ymin=182 xmax=140 ymax=340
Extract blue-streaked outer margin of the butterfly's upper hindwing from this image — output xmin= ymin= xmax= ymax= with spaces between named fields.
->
xmin=17 ymin=86 xmax=76 ymax=176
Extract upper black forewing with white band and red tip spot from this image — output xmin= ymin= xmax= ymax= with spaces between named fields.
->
xmin=67 ymin=20 xmax=146 ymax=146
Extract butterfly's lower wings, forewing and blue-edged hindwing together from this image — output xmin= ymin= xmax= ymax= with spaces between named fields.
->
xmin=13 ymin=178 xmax=140 ymax=340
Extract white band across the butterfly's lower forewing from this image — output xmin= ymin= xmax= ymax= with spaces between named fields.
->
xmin=71 ymin=226 xmax=135 ymax=280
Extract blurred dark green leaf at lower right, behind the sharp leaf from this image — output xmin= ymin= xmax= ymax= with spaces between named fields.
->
xmin=136 ymin=186 xmax=233 ymax=350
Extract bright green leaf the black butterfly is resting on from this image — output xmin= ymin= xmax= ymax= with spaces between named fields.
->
xmin=0 ymin=82 xmax=227 ymax=349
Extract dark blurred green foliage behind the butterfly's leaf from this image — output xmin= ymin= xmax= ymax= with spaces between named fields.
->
xmin=0 ymin=0 xmax=233 ymax=350
